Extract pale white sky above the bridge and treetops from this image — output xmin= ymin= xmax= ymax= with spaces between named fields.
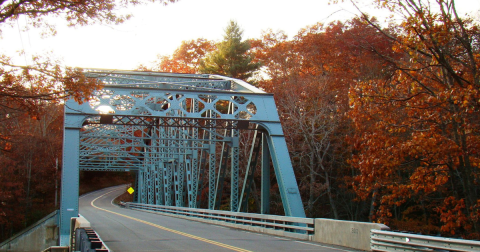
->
xmin=0 ymin=0 xmax=480 ymax=70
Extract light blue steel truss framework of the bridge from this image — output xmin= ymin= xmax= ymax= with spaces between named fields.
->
xmin=60 ymin=69 xmax=305 ymax=245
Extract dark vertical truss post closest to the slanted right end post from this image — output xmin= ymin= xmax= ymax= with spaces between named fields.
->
xmin=260 ymin=134 xmax=270 ymax=214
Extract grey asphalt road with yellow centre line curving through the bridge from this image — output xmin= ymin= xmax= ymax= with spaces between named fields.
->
xmin=79 ymin=186 xmax=353 ymax=252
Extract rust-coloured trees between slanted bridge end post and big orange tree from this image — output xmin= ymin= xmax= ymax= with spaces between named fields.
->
xmin=252 ymin=19 xmax=396 ymax=220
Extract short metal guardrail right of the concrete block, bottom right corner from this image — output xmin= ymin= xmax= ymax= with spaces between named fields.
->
xmin=371 ymin=230 xmax=480 ymax=251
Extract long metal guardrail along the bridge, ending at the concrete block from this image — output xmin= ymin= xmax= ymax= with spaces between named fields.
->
xmin=121 ymin=202 xmax=315 ymax=240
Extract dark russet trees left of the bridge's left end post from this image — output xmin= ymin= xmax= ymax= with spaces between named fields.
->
xmin=0 ymin=104 xmax=63 ymax=240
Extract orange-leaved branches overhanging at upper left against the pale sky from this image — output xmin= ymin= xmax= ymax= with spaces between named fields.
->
xmin=0 ymin=0 xmax=175 ymax=152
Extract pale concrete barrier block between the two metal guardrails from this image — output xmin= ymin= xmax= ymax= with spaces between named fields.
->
xmin=313 ymin=219 xmax=390 ymax=251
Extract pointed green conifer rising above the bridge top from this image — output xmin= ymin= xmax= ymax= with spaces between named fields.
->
xmin=199 ymin=21 xmax=260 ymax=80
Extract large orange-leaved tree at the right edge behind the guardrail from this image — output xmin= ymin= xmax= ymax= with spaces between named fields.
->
xmin=349 ymin=0 xmax=480 ymax=238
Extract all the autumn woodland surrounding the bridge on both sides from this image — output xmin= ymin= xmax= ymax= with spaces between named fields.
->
xmin=0 ymin=0 xmax=480 ymax=242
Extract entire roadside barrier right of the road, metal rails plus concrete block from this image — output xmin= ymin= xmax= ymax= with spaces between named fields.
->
xmin=122 ymin=203 xmax=480 ymax=251
